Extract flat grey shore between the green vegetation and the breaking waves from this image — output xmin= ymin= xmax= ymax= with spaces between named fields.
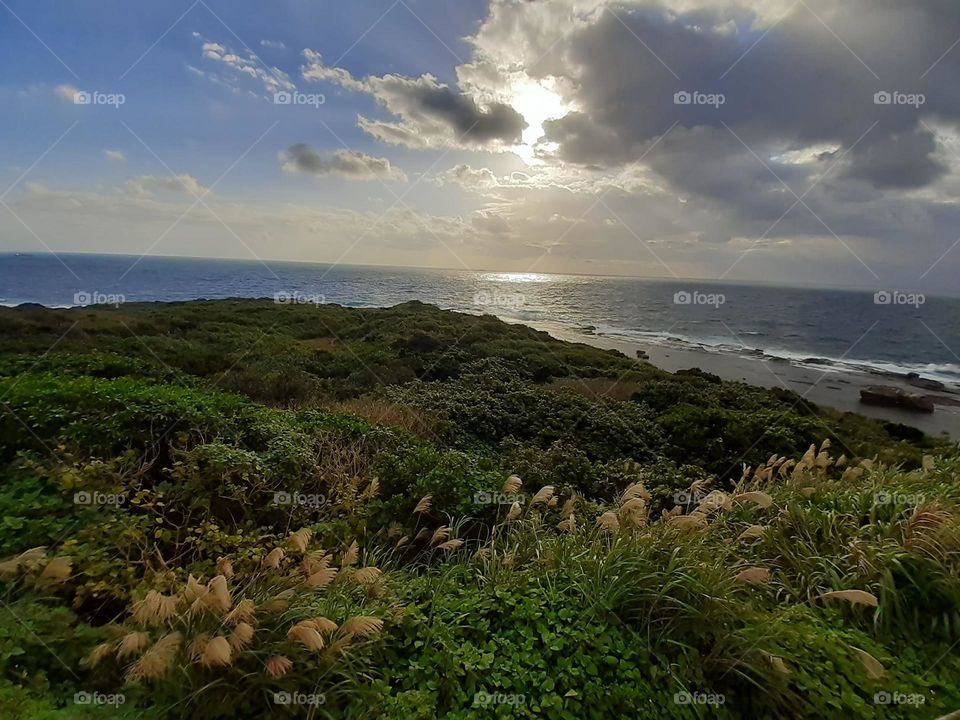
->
xmin=520 ymin=320 xmax=960 ymax=440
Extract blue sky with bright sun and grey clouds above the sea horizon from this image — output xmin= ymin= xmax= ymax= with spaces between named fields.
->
xmin=0 ymin=0 xmax=960 ymax=294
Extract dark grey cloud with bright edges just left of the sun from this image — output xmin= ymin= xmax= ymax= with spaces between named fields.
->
xmin=301 ymin=49 xmax=527 ymax=147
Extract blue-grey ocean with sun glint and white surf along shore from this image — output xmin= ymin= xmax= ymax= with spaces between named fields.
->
xmin=0 ymin=253 xmax=960 ymax=385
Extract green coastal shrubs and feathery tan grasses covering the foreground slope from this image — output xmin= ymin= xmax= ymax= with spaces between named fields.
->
xmin=0 ymin=300 xmax=960 ymax=720
